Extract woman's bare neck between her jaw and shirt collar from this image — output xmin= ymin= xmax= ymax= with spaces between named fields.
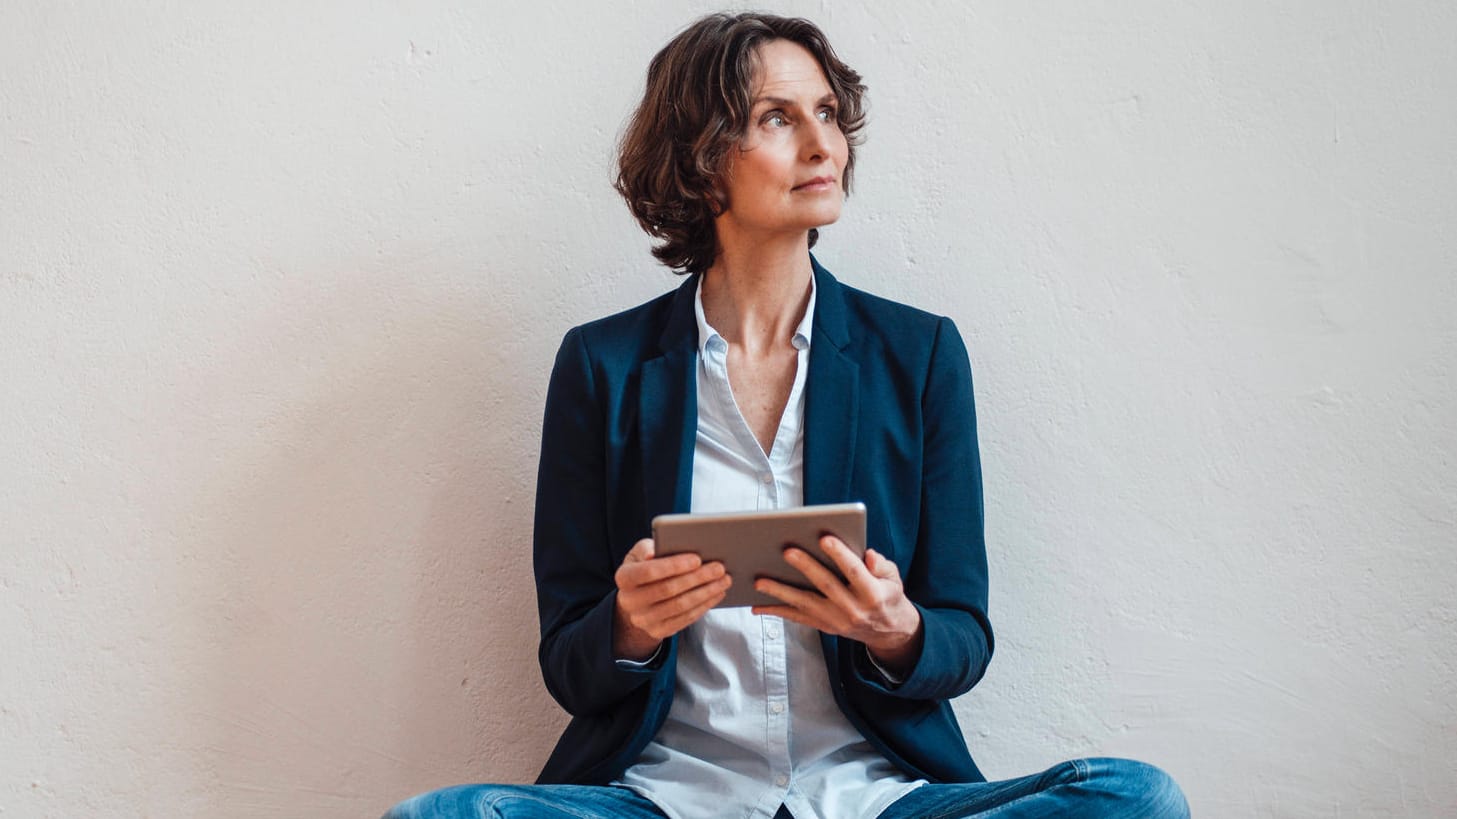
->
xmin=704 ymin=227 xmax=814 ymax=354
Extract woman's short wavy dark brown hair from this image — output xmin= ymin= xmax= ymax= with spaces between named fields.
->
xmin=613 ymin=13 xmax=865 ymax=273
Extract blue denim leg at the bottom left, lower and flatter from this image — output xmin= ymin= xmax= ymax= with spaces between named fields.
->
xmin=383 ymin=785 xmax=664 ymax=819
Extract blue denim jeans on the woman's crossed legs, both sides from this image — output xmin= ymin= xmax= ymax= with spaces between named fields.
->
xmin=385 ymin=758 xmax=1189 ymax=819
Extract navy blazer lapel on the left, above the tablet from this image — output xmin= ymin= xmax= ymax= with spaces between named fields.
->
xmin=638 ymin=275 xmax=698 ymax=520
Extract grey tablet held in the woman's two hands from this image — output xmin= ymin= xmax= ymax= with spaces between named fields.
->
xmin=653 ymin=503 xmax=865 ymax=608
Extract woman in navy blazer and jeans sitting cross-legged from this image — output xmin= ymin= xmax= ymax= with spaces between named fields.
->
xmin=392 ymin=15 xmax=1187 ymax=819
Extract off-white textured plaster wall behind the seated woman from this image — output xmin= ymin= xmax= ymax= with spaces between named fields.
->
xmin=0 ymin=0 xmax=1457 ymax=818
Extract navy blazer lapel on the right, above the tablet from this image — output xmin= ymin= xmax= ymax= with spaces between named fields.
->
xmin=804 ymin=256 xmax=860 ymax=506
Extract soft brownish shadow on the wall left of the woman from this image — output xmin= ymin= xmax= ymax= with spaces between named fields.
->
xmin=178 ymin=265 xmax=565 ymax=816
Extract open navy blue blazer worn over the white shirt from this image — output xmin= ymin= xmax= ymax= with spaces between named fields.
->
xmin=533 ymin=259 xmax=992 ymax=784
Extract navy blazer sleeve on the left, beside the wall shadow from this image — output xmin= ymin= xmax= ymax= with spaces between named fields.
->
xmin=532 ymin=328 xmax=660 ymax=716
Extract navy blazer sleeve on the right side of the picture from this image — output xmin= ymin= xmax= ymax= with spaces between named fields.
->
xmin=854 ymin=318 xmax=994 ymax=700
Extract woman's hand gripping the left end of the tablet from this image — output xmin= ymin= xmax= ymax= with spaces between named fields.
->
xmin=612 ymin=538 xmax=733 ymax=662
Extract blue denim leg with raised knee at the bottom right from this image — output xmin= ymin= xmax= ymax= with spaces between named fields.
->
xmin=880 ymin=758 xmax=1189 ymax=819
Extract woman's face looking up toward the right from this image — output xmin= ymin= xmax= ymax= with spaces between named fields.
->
xmin=717 ymin=39 xmax=849 ymax=238
